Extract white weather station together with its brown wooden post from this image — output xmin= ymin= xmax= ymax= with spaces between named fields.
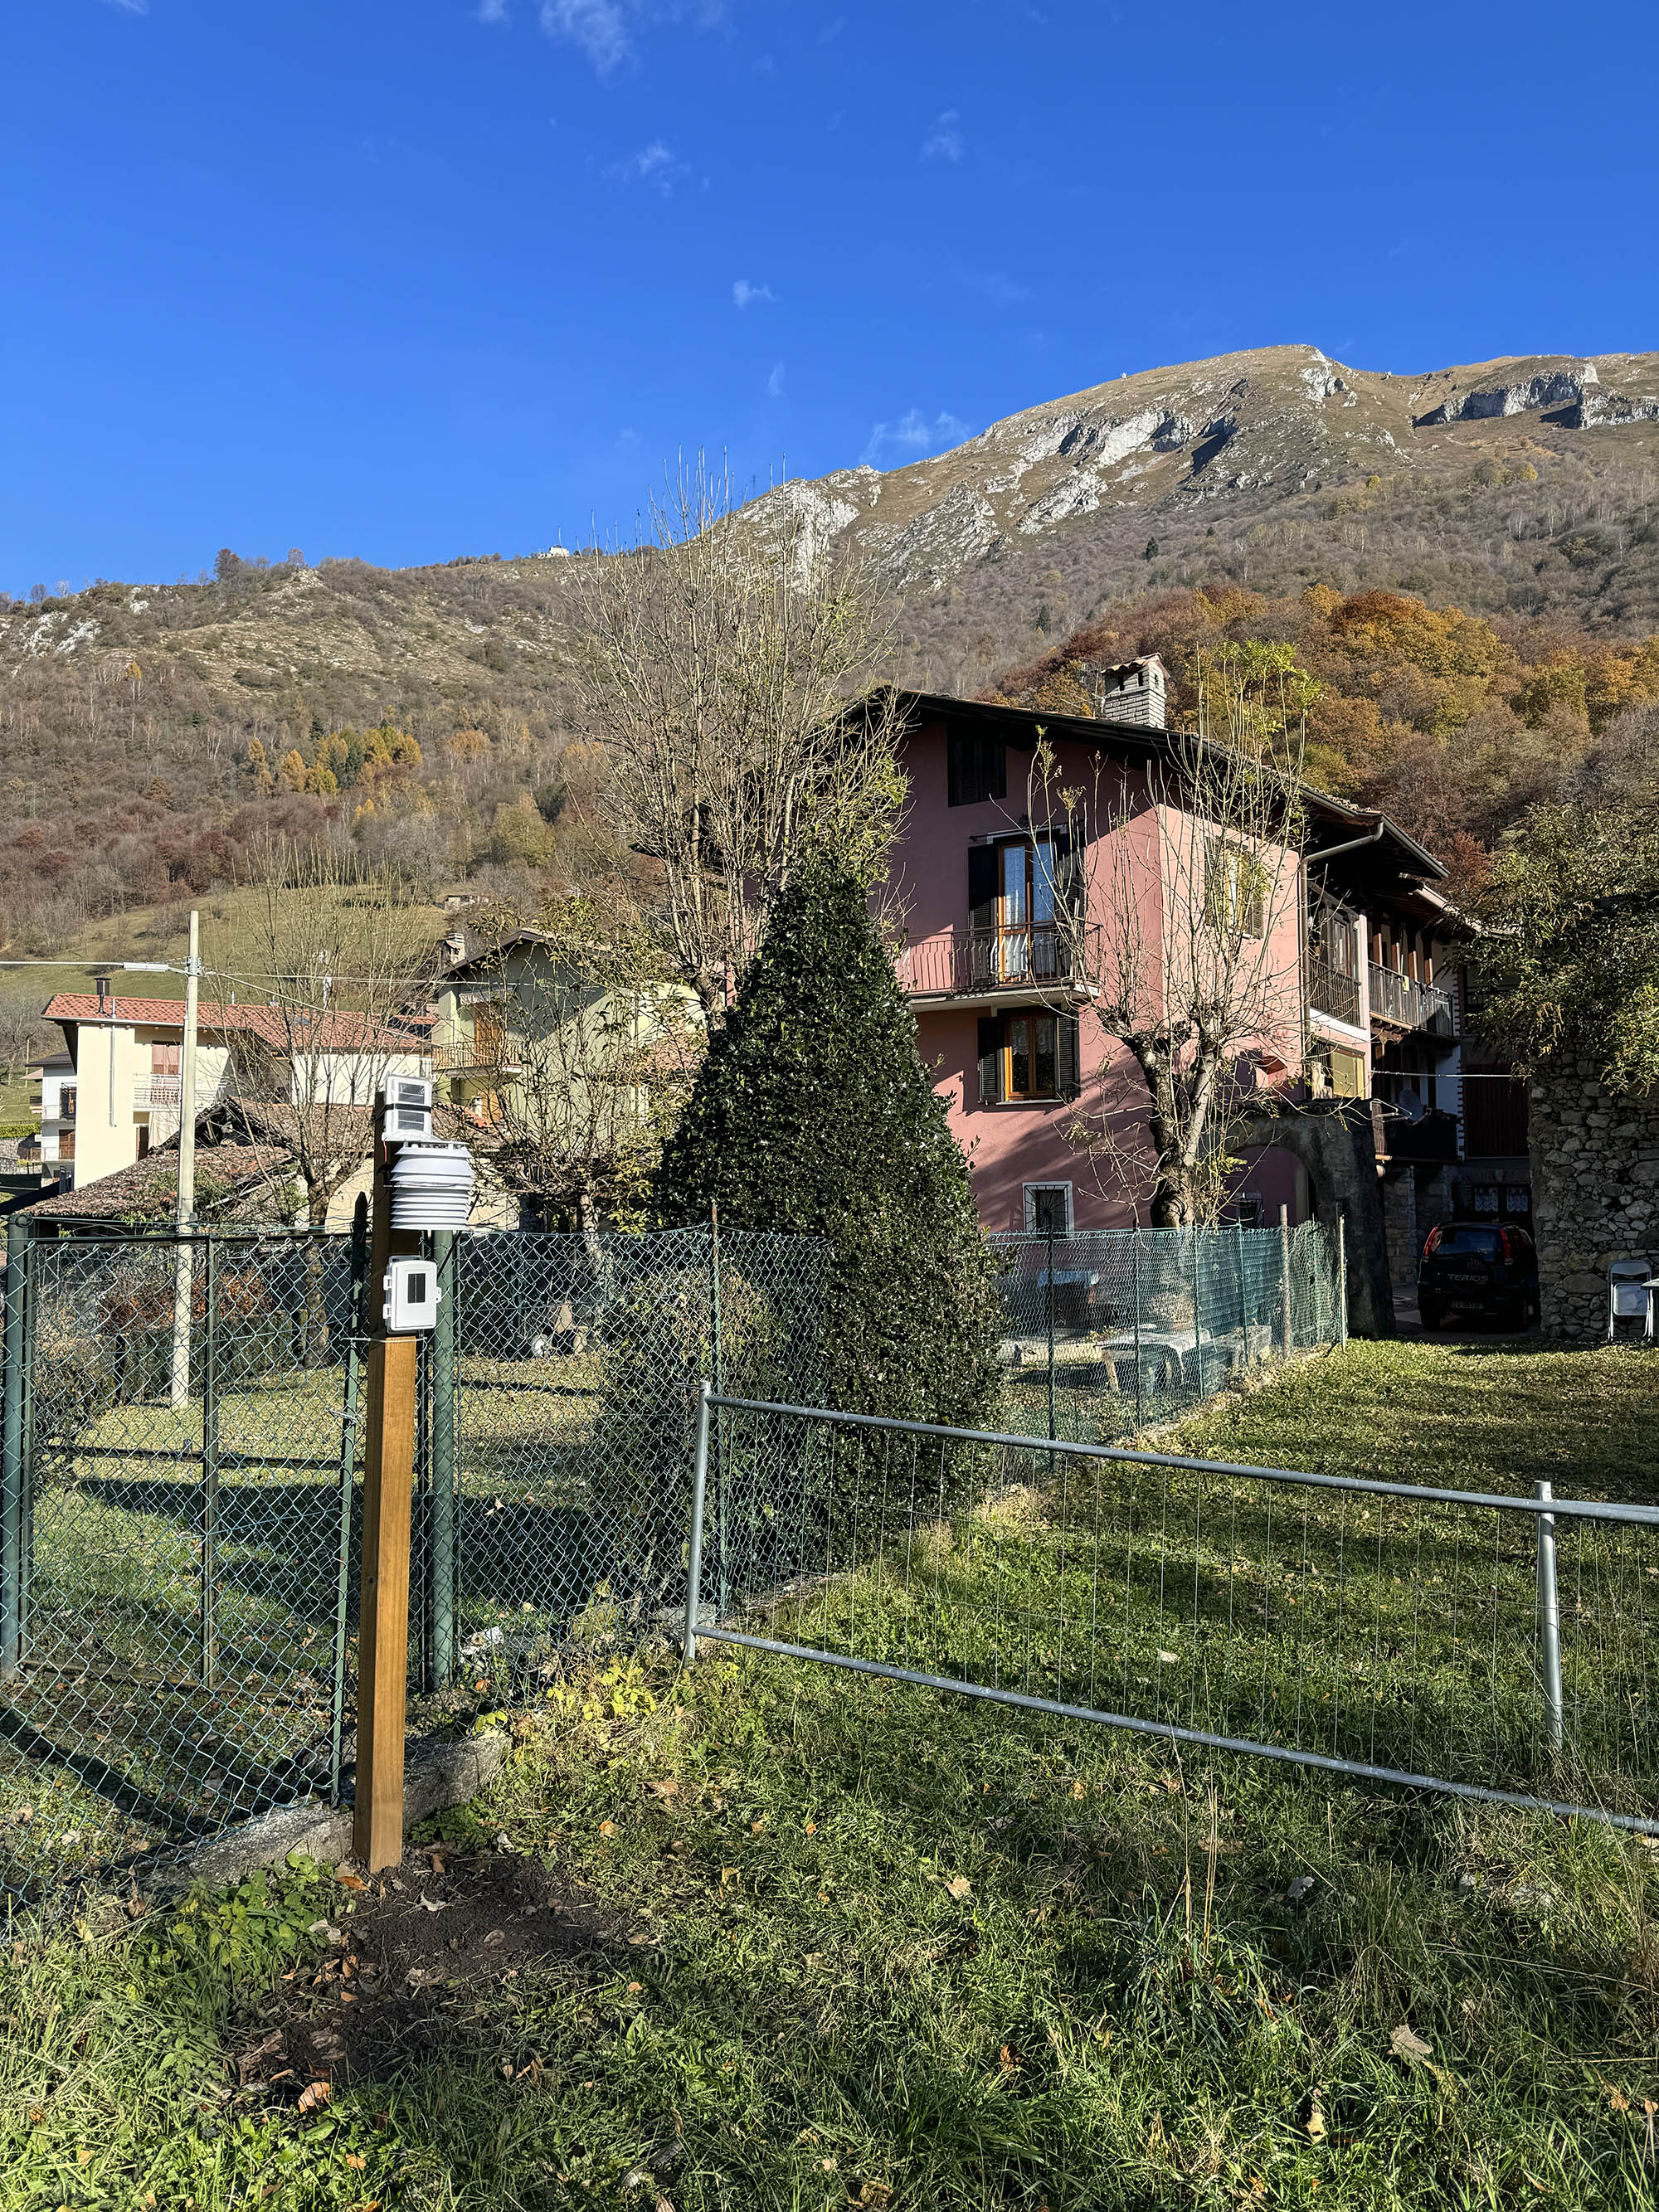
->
xmin=352 ymin=1077 xmax=474 ymax=1874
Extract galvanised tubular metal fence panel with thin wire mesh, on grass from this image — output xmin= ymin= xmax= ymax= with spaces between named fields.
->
xmin=697 ymin=1396 xmax=1659 ymax=1830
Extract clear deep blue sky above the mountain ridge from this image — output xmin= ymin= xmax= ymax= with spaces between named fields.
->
xmin=0 ymin=0 xmax=1659 ymax=593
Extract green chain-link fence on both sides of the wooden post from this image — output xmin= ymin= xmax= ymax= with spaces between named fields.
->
xmin=0 ymin=1230 xmax=827 ymax=1896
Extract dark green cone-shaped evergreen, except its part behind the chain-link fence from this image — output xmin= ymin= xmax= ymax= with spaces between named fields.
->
xmin=657 ymin=860 xmax=1002 ymax=1427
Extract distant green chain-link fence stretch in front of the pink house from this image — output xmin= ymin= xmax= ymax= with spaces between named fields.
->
xmin=991 ymin=1221 xmax=1347 ymax=1442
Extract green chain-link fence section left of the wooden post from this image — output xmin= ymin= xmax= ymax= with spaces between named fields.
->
xmin=0 ymin=1232 xmax=358 ymax=1887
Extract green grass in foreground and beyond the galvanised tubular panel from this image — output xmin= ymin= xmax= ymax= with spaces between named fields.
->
xmin=0 ymin=1345 xmax=1659 ymax=2212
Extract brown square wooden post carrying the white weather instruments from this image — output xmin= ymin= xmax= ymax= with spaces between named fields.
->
xmin=352 ymin=1104 xmax=421 ymax=1874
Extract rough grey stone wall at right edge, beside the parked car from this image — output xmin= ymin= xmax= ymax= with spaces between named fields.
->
xmin=1529 ymin=1064 xmax=1659 ymax=1343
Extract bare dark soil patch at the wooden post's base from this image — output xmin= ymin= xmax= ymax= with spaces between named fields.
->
xmin=232 ymin=1845 xmax=640 ymax=2110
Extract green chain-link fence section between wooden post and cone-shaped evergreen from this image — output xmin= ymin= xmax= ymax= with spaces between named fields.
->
xmin=440 ymin=1230 xmax=830 ymax=1690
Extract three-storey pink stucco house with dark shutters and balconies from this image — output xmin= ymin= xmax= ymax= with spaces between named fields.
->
xmin=887 ymin=661 xmax=1495 ymax=1256
